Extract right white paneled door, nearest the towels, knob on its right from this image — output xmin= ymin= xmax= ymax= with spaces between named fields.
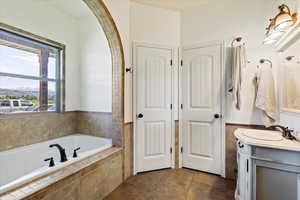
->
xmin=182 ymin=44 xmax=222 ymax=174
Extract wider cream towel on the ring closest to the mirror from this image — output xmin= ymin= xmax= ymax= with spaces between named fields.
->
xmin=254 ymin=67 xmax=278 ymax=127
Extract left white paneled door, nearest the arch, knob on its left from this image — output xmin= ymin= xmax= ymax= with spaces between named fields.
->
xmin=134 ymin=45 xmax=172 ymax=172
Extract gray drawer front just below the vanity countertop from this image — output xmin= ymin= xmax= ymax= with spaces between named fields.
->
xmin=252 ymin=147 xmax=300 ymax=166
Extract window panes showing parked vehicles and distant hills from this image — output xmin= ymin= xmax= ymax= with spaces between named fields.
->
xmin=0 ymin=29 xmax=61 ymax=114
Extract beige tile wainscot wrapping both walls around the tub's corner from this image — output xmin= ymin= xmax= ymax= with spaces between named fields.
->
xmin=0 ymin=111 xmax=122 ymax=151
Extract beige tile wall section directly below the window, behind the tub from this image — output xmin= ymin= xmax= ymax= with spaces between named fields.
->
xmin=0 ymin=112 xmax=77 ymax=151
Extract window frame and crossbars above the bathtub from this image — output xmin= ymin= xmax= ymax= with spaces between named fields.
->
xmin=0 ymin=23 xmax=66 ymax=117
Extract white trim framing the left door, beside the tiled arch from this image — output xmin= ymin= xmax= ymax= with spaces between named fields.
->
xmin=132 ymin=41 xmax=178 ymax=175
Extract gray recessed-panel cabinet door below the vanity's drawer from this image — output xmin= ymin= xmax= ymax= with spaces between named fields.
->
xmin=253 ymin=160 xmax=300 ymax=200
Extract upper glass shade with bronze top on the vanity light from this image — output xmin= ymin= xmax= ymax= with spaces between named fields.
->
xmin=274 ymin=4 xmax=297 ymax=31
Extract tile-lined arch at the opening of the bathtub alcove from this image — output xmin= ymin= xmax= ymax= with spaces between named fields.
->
xmin=83 ymin=0 xmax=125 ymax=146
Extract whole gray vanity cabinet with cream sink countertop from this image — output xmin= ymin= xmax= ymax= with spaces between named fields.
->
xmin=234 ymin=129 xmax=300 ymax=200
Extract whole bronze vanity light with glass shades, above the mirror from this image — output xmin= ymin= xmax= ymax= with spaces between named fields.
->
xmin=263 ymin=4 xmax=297 ymax=44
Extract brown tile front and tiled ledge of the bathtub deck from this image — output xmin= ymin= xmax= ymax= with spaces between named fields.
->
xmin=0 ymin=148 xmax=123 ymax=200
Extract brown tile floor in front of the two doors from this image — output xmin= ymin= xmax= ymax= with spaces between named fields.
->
xmin=105 ymin=169 xmax=235 ymax=200
